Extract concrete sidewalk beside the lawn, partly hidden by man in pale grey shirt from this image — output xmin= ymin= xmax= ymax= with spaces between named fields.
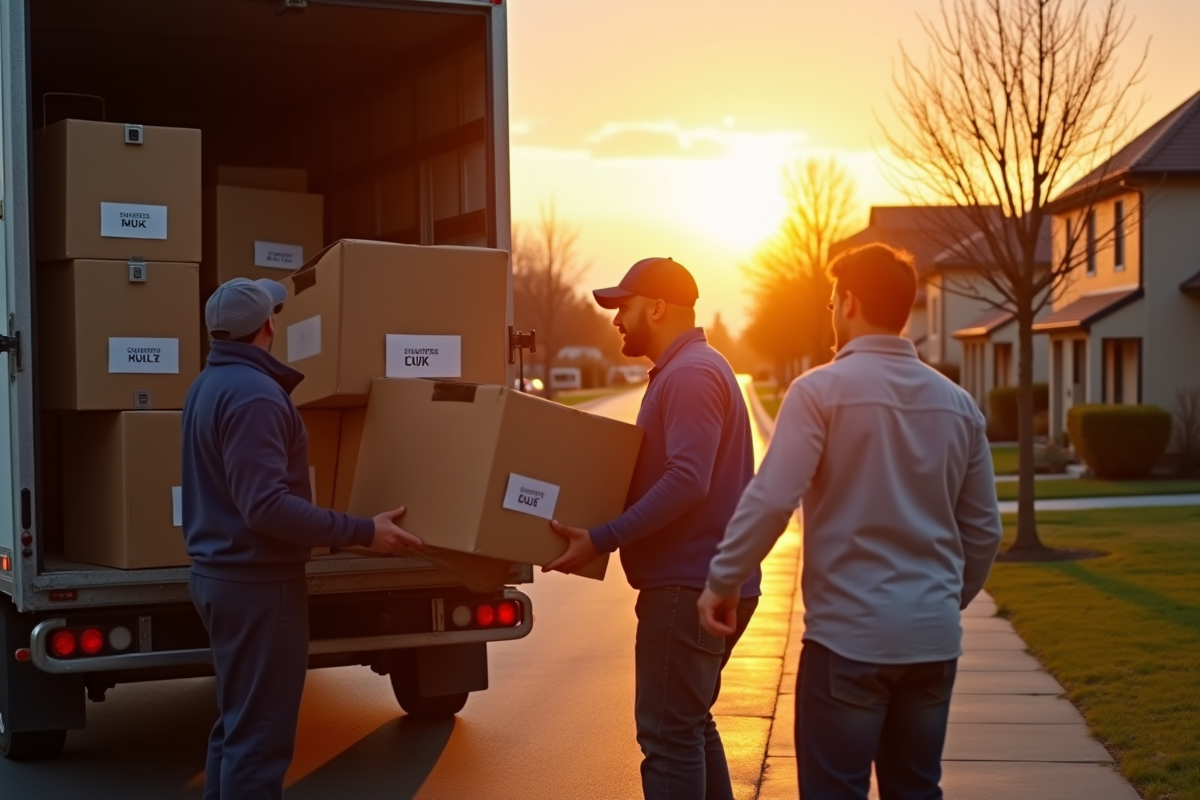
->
xmin=739 ymin=379 xmax=1142 ymax=800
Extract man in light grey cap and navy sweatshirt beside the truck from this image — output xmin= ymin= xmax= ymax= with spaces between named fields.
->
xmin=184 ymin=278 xmax=421 ymax=800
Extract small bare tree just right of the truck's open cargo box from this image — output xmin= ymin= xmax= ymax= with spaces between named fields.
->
xmin=512 ymin=203 xmax=588 ymax=396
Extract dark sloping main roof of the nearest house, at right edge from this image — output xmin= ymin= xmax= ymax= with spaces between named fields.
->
xmin=1055 ymin=92 xmax=1200 ymax=205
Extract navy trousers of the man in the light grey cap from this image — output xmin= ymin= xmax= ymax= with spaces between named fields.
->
xmin=188 ymin=572 xmax=308 ymax=800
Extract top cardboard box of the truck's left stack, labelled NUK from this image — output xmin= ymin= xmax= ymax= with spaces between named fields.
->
xmin=34 ymin=120 xmax=200 ymax=263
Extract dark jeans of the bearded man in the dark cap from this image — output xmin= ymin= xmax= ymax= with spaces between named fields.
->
xmin=634 ymin=587 xmax=758 ymax=800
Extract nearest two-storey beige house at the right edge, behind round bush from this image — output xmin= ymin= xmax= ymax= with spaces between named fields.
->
xmin=1034 ymin=94 xmax=1200 ymax=435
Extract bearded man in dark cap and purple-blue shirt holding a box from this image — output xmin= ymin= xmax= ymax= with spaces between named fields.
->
xmin=544 ymin=258 xmax=762 ymax=800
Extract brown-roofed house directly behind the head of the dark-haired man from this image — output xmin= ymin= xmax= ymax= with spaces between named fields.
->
xmin=832 ymin=205 xmax=971 ymax=363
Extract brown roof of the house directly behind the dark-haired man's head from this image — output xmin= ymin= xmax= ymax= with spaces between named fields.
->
xmin=830 ymin=205 xmax=976 ymax=275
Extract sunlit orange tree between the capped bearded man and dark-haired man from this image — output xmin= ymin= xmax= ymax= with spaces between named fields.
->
xmin=743 ymin=158 xmax=857 ymax=380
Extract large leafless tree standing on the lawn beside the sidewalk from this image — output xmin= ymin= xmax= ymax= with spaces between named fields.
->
xmin=884 ymin=0 xmax=1146 ymax=551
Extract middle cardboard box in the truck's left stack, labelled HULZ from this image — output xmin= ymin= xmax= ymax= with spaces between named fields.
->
xmin=37 ymin=260 xmax=200 ymax=411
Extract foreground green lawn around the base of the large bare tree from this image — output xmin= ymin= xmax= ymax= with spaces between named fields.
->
xmin=988 ymin=507 xmax=1200 ymax=800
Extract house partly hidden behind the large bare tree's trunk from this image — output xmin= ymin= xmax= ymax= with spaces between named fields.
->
xmin=945 ymin=225 xmax=1050 ymax=413
